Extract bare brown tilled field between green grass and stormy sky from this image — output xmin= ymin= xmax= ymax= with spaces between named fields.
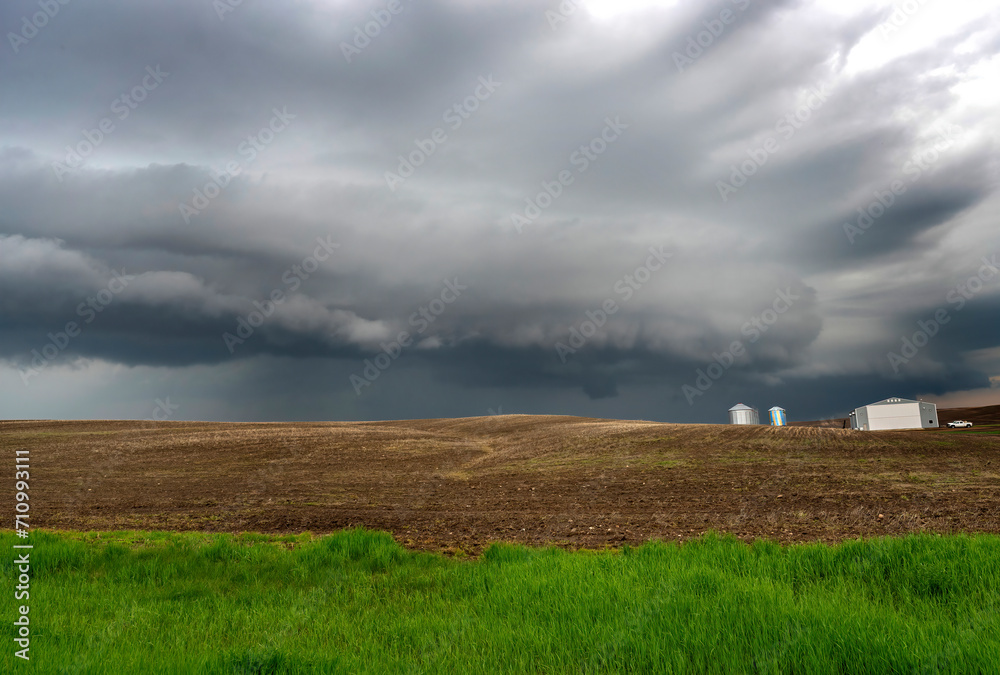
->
xmin=0 ymin=415 xmax=1000 ymax=553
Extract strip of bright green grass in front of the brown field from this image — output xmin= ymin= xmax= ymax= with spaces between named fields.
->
xmin=0 ymin=530 xmax=1000 ymax=673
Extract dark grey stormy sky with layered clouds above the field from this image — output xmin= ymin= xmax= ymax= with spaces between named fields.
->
xmin=0 ymin=0 xmax=1000 ymax=422
